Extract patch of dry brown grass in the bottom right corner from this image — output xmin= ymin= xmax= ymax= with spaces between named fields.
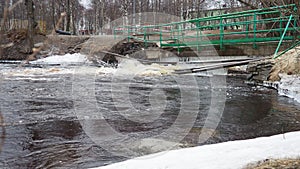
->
xmin=244 ymin=158 xmax=300 ymax=169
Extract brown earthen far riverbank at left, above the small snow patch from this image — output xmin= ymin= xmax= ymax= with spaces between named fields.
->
xmin=0 ymin=30 xmax=90 ymax=60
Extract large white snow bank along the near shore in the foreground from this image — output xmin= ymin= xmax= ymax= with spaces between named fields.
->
xmin=91 ymin=132 xmax=300 ymax=169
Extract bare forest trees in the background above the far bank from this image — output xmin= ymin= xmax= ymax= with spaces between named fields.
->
xmin=0 ymin=0 xmax=299 ymax=34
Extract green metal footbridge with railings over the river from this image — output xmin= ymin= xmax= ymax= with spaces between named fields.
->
xmin=114 ymin=4 xmax=300 ymax=57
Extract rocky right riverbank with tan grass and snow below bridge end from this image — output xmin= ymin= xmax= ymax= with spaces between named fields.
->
xmin=246 ymin=47 xmax=300 ymax=102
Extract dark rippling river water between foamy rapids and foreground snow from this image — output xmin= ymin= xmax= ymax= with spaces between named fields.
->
xmin=0 ymin=65 xmax=300 ymax=169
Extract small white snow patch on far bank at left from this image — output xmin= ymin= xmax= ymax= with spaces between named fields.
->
xmin=30 ymin=53 xmax=88 ymax=64
